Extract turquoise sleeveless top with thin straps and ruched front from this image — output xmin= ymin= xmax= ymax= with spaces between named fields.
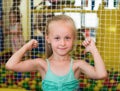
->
xmin=42 ymin=59 xmax=79 ymax=91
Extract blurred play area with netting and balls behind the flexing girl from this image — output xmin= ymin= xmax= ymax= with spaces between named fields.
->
xmin=0 ymin=0 xmax=120 ymax=91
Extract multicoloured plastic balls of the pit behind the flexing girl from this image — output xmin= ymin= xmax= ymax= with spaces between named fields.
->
xmin=0 ymin=59 xmax=120 ymax=91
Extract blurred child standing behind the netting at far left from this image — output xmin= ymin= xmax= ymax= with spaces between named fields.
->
xmin=5 ymin=8 xmax=24 ymax=53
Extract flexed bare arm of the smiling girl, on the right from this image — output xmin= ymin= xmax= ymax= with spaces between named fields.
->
xmin=79 ymin=38 xmax=107 ymax=79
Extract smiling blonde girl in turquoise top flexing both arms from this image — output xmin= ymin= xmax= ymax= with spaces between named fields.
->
xmin=6 ymin=15 xmax=107 ymax=91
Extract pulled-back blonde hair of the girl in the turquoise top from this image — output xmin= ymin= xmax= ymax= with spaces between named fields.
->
xmin=46 ymin=15 xmax=76 ymax=58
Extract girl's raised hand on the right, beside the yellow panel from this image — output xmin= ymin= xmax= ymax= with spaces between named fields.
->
xmin=82 ymin=37 xmax=96 ymax=52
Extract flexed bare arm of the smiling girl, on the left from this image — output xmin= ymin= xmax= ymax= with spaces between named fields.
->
xmin=6 ymin=40 xmax=42 ymax=72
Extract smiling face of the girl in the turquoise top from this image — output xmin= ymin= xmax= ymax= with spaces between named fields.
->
xmin=46 ymin=21 xmax=74 ymax=55
